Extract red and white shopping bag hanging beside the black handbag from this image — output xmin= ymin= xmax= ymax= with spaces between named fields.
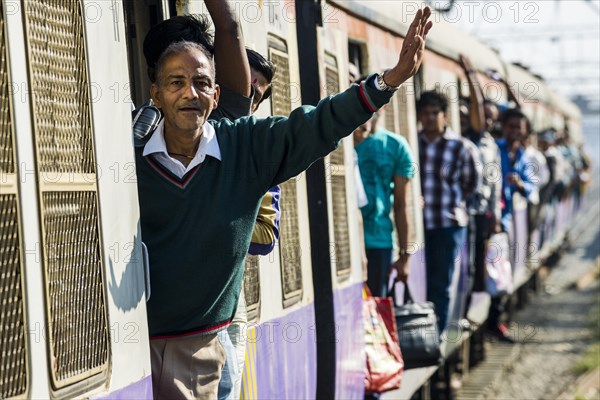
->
xmin=363 ymin=285 xmax=404 ymax=394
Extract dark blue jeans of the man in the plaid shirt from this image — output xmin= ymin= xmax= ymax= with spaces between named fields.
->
xmin=425 ymin=226 xmax=467 ymax=334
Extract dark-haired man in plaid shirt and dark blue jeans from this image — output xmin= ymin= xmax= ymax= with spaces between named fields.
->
xmin=417 ymin=91 xmax=481 ymax=332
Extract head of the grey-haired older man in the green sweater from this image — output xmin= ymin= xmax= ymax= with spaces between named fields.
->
xmin=150 ymin=50 xmax=219 ymax=135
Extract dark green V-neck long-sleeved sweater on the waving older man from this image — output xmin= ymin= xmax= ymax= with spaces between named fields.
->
xmin=136 ymin=77 xmax=392 ymax=337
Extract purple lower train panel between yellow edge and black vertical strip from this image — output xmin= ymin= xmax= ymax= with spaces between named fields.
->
xmin=256 ymin=304 xmax=317 ymax=399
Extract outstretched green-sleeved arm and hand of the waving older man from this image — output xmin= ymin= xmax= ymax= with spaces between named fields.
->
xmin=218 ymin=8 xmax=431 ymax=191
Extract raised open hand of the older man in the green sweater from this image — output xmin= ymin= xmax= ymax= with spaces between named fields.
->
xmin=383 ymin=7 xmax=433 ymax=86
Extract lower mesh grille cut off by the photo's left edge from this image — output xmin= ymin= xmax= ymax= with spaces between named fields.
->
xmin=0 ymin=194 xmax=27 ymax=399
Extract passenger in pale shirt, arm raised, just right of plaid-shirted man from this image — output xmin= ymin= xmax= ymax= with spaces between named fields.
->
xmin=460 ymin=55 xmax=502 ymax=300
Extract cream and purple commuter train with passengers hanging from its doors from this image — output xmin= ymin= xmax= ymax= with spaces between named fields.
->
xmin=0 ymin=0 xmax=582 ymax=399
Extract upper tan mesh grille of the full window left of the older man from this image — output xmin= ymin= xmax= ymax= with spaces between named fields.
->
xmin=25 ymin=0 xmax=95 ymax=174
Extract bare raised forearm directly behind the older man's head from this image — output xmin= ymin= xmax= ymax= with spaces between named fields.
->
xmin=204 ymin=0 xmax=251 ymax=97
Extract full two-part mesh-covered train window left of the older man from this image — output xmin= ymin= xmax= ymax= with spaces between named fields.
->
xmin=24 ymin=1 xmax=110 ymax=393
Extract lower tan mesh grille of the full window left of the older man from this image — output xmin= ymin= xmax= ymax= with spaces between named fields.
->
xmin=42 ymin=192 xmax=108 ymax=383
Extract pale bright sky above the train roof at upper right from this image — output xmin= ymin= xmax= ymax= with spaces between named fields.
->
xmin=450 ymin=0 xmax=600 ymax=108
